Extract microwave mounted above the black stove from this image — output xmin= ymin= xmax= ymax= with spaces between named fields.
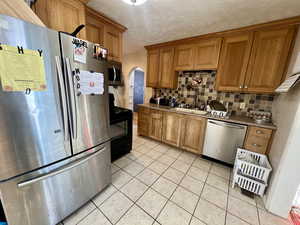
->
xmin=108 ymin=61 xmax=123 ymax=86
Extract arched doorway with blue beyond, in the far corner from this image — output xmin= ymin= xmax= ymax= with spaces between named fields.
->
xmin=129 ymin=67 xmax=145 ymax=112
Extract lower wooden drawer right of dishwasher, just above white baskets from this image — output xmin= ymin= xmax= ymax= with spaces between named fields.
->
xmin=245 ymin=136 xmax=270 ymax=154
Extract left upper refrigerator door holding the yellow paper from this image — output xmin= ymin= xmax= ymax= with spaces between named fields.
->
xmin=0 ymin=15 xmax=72 ymax=181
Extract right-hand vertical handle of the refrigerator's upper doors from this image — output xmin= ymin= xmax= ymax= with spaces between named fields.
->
xmin=65 ymin=57 xmax=77 ymax=140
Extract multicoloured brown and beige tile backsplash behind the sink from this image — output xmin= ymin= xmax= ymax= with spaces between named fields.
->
xmin=154 ymin=71 xmax=274 ymax=115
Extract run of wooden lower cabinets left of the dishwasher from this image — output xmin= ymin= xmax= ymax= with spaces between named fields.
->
xmin=138 ymin=106 xmax=206 ymax=154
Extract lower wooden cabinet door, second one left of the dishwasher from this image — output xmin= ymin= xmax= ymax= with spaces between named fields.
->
xmin=162 ymin=112 xmax=182 ymax=147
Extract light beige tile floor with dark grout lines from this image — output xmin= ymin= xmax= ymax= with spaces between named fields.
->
xmin=63 ymin=127 xmax=288 ymax=225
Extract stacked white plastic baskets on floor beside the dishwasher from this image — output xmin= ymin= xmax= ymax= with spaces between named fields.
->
xmin=232 ymin=148 xmax=272 ymax=196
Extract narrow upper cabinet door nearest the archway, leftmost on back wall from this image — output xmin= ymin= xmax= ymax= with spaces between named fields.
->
xmin=147 ymin=49 xmax=159 ymax=88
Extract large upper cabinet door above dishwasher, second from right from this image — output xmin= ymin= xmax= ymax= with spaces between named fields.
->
xmin=216 ymin=33 xmax=253 ymax=91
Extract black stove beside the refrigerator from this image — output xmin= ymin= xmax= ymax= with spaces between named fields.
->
xmin=109 ymin=93 xmax=133 ymax=161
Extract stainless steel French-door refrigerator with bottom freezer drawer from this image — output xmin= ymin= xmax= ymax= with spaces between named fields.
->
xmin=0 ymin=15 xmax=111 ymax=225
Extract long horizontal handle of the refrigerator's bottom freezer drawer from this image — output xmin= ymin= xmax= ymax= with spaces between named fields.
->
xmin=18 ymin=147 xmax=105 ymax=188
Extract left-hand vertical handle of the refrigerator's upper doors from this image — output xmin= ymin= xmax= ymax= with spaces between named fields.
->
xmin=55 ymin=56 xmax=68 ymax=141
